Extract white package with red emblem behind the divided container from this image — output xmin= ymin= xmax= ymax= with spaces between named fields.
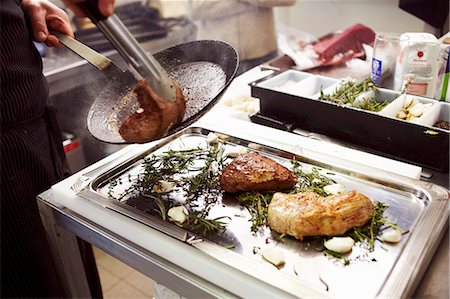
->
xmin=394 ymin=32 xmax=440 ymax=98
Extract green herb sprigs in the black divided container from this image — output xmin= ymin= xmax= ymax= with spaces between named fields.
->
xmin=319 ymin=78 xmax=388 ymax=112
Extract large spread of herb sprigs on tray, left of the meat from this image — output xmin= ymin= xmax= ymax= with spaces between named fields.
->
xmin=108 ymin=144 xmax=226 ymax=235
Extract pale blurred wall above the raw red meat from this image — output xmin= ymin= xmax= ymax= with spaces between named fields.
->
xmin=275 ymin=0 xmax=434 ymax=37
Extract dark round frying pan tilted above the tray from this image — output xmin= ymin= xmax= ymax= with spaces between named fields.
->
xmin=87 ymin=40 xmax=239 ymax=143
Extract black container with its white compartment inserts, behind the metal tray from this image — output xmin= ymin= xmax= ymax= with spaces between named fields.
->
xmin=250 ymin=70 xmax=450 ymax=172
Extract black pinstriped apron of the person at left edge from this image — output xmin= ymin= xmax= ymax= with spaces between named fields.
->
xmin=0 ymin=0 xmax=102 ymax=298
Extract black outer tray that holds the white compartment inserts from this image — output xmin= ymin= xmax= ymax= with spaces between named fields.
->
xmin=250 ymin=73 xmax=449 ymax=172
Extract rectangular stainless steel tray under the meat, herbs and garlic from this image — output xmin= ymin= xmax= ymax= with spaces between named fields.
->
xmin=79 ymin=127 xmax=450 ymax=297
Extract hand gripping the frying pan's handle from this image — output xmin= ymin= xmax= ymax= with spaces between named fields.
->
xmin=21 ymin=0 xmax=73 ymax=48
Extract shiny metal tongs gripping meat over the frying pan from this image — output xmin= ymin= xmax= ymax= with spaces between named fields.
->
xmin=77 ymin=0 xmax=176 ymax=101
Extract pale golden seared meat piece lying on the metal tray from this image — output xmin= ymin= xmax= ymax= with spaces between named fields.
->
xmin=268 ymin=191 xmax=374 ymax=240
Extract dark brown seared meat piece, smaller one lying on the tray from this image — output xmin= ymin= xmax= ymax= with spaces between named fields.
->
xmin=220 ymin=152 xmax=297 ymax=193
